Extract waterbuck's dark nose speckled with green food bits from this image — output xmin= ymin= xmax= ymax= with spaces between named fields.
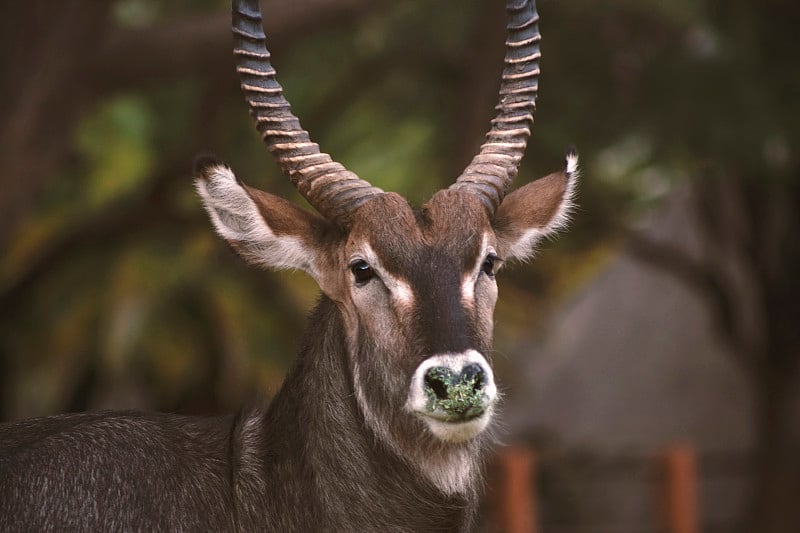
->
xmin=424 ymin=363 xmax=488 ymax=420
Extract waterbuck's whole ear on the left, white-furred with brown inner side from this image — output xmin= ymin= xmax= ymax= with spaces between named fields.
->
xmin=195 ymin=157 xmax=327 ymax=279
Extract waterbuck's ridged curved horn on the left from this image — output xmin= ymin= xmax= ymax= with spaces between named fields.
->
xmin=232 ymin=0 xmax=383 ymax=226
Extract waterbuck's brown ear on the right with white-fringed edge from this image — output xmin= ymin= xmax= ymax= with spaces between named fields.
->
xmin=494 ymin=149 xmax=578 ymax=260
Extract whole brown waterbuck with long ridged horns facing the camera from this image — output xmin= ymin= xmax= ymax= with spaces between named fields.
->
xmin=0 ymin=0 xmax=577 ymax=532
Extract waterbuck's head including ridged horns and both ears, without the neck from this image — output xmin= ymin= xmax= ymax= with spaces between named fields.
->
xmin=196 ymin=0 xmax=577 ymax=484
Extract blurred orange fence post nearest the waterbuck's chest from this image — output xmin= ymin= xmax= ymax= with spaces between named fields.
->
xmin=497 ymin=446 xmax=539 ymax=533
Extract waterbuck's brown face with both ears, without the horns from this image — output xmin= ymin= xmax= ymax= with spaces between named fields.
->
xmin=197 ymin=155 xmax=577 ymax=450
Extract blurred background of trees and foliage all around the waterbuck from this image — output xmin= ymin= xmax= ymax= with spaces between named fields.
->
xmin=0 ymin=0 xmax=800 ymax=533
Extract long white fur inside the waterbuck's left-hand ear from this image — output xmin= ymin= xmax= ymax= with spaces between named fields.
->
xmin=195 ymin=165 xmax=317 ymax=279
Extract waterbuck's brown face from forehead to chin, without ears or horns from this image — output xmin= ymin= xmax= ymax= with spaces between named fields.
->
xmin=342 ymin=191 xmax=501 ymax=442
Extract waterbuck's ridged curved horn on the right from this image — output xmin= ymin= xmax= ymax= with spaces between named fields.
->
xmin=450 ymin=0 xmax=541 ymax=213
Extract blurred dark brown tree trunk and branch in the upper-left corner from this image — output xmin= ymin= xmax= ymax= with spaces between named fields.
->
xmin=0 ymin=0 xmax=387 ymax=243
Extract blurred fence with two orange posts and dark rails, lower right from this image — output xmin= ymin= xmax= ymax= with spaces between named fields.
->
xmin=482 ymin=445 xmax=748 ymax=533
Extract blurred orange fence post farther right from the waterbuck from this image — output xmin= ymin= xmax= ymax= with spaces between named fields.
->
xmin=657 ymin=446 xmax=700 ymax=533
